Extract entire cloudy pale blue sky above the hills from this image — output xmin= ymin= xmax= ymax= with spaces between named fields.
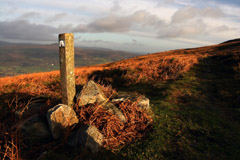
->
xmin=0 ymin=0 xmax=240 ymax=53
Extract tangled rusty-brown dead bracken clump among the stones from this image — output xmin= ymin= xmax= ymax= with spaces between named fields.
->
xmin=76 ymin=100 xmax=153 ymax=150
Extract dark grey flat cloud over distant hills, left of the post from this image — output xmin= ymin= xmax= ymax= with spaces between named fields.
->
xmin=0 ymin=20 xmax=70 ymax=41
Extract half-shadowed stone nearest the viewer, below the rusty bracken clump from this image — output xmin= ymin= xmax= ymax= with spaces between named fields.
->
xmin=68 ymin=125 xmax=104 ymax=153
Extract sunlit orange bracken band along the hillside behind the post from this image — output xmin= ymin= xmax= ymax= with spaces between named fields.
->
xmin=0 ymin=41 xmax=240 ymax=98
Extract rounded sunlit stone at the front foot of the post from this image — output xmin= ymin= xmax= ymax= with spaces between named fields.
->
xmin=47 ymin=104 xmax=79 ymax=139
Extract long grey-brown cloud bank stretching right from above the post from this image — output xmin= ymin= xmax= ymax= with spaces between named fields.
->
xmin=73 ymin=5 xmax=225 ymax=38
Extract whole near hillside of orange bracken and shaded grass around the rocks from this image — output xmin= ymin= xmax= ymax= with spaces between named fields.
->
xmin=0 ymin=41 xmax=240 ymax=160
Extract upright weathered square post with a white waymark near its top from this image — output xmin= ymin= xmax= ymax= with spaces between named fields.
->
xmin=59 ymin=33 xmax=76 ymax=106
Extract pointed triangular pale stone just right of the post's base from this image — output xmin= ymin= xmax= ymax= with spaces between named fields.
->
xmin=77 ymin=80 xmax=107 ymax=106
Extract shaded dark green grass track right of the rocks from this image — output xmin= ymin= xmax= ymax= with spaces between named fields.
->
xmin=103 ymin=54 xmax=240 ymax=159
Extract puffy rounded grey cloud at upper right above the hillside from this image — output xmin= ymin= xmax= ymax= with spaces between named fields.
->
xmin=158 ymin=6 xmax=225 ymax=38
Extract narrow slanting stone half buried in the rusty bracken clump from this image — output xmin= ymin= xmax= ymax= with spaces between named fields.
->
xmin=102 ymin=102 xmax=127 ymax=123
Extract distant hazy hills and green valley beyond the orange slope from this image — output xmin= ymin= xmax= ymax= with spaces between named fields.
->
xmin=0 ymin=41 xmax=140 ymax=77
